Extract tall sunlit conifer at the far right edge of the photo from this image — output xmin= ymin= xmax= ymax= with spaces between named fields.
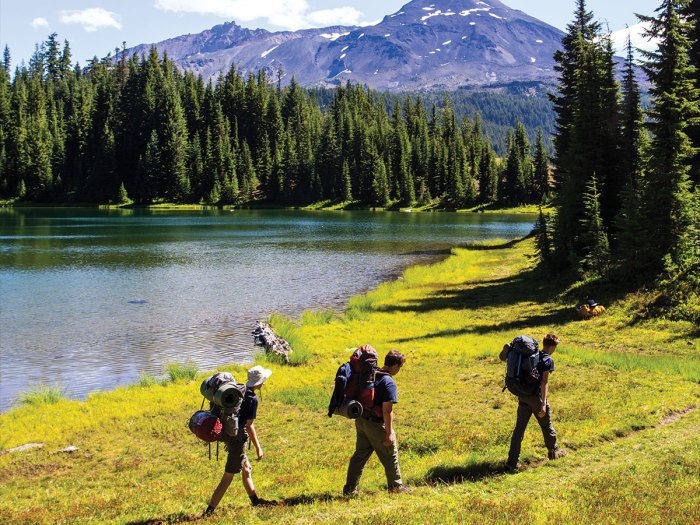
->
xmin=640 ymin=0 xmax=700 ymax=275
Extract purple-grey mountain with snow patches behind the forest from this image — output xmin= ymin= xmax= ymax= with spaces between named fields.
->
xmin=127 ymin=0 xmax=563 ymax=91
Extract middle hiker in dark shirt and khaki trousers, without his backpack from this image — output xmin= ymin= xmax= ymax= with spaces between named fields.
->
xmin=343 ymin=350 xmax=406 ymax=496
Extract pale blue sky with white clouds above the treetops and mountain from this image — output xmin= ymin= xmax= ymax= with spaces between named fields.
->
xmin=0 ymin=0 xmax=660 ymax=66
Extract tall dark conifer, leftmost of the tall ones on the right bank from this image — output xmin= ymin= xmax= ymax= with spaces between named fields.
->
xmin=552 ymin=0 xmax=621 ymax=265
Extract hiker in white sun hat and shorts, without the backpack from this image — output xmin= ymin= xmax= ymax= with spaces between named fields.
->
xmin=204 ymin=365 xmax=275 ymax=515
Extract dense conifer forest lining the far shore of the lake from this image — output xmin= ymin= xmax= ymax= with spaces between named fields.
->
xmin=0 ymin=34 xmax=551 ymax=207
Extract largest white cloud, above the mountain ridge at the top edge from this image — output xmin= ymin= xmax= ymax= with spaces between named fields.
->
xmin=155 ymin=0 xmax=362 ymax=30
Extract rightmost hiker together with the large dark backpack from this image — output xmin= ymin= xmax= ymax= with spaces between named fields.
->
xmin=499 ymin=334 xmax=567 ymax=469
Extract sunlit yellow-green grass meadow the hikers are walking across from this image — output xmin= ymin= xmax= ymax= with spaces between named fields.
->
xmin=0 ymin=240 xmax=700 ymax=524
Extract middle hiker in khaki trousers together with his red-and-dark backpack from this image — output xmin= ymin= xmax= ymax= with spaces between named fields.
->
xmin=340 ymin=345 xmax=407 ymax=497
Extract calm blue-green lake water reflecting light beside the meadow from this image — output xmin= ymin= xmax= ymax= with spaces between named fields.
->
xmin=0 ymin=209 xmax=535 ymax=410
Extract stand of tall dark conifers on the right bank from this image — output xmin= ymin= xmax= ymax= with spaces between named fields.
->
xmin=538 ymin=0 xmax=700 ymax=322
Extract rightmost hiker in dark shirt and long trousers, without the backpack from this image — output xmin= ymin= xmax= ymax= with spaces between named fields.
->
xmin=499 ymin=334 xmax=567 ymax=469
